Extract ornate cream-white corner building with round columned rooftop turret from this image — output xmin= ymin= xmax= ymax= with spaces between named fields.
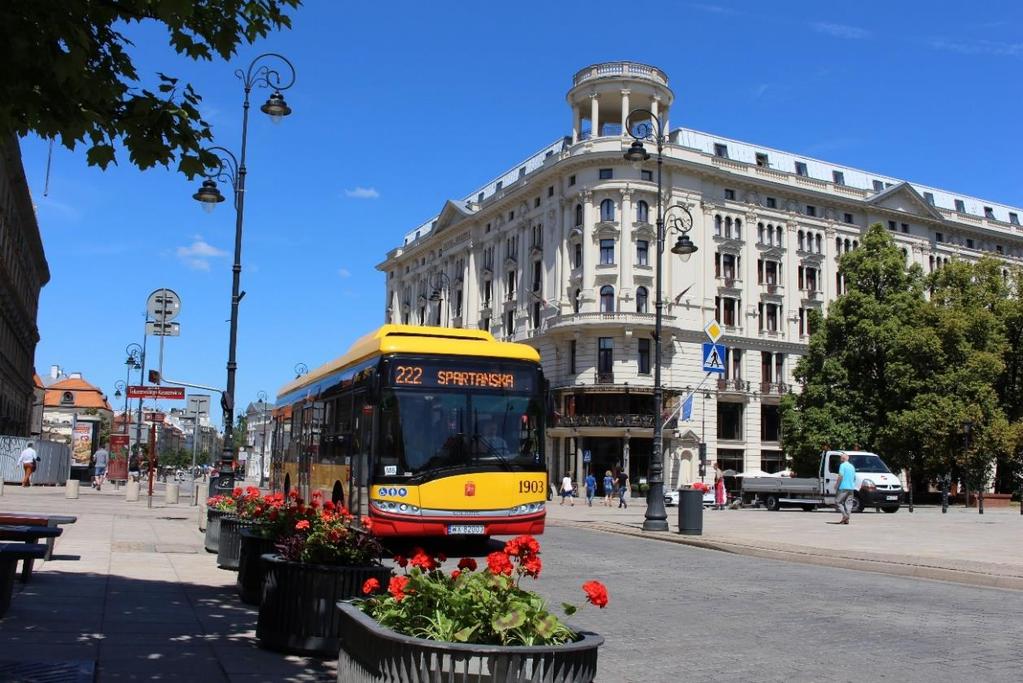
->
xmin=377 ymin=62 xmax=1023 ymax=488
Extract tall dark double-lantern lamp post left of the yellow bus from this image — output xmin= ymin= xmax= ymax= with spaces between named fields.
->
xmin=192 ymin=52 xmax=295 ymax=494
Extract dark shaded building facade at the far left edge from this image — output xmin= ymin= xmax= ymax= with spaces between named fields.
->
xmin=0 ymin=136 xmax=50 ymax=437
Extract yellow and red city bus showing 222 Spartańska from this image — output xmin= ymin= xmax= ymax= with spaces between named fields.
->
xmin=271 ymin=325 xmax=547 ymax=537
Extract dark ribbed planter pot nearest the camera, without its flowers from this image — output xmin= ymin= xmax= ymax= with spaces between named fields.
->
xmin=338 ymin=602 xmax=604 ymax=683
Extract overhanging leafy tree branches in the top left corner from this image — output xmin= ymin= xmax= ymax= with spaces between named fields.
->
xmin=0 ymin=0 xmax=301 ymax=177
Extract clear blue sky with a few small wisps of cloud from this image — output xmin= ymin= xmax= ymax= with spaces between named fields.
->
xmin=23 ymin=0 xmax=1023 ymax=427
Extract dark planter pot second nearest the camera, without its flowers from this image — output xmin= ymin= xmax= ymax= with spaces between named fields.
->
xmin=256 ymin=554 xmax=391 ymax=657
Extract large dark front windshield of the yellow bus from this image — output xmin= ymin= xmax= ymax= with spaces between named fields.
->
xmin=374 ymin=390 xmax=544 ymax=477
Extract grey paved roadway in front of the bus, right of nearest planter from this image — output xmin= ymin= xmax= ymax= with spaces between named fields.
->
xmin=499 ymin=526 xmax=1023 ymax=683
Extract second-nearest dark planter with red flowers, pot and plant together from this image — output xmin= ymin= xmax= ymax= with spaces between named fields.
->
xmin=256 ymin=492 xmax=391 ymax=656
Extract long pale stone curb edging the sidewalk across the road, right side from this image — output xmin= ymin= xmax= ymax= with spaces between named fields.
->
xmin=547 ymin=519 xmax=1023 ymax=591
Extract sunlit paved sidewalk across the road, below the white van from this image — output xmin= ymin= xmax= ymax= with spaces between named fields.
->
xmin=547 ymin=499 xmax=1023 ymax=590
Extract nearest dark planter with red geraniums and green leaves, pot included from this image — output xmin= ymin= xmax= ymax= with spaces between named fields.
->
xmin=338 ymin=536 xmax=608 ymax=683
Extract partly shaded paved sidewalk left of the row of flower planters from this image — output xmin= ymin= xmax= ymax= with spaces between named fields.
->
xmin=0 ymin=486 xmax=336 ymax=683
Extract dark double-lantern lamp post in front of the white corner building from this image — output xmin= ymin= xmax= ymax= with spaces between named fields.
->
xmin=625 ymin=109 xmax=698 ymax=532
